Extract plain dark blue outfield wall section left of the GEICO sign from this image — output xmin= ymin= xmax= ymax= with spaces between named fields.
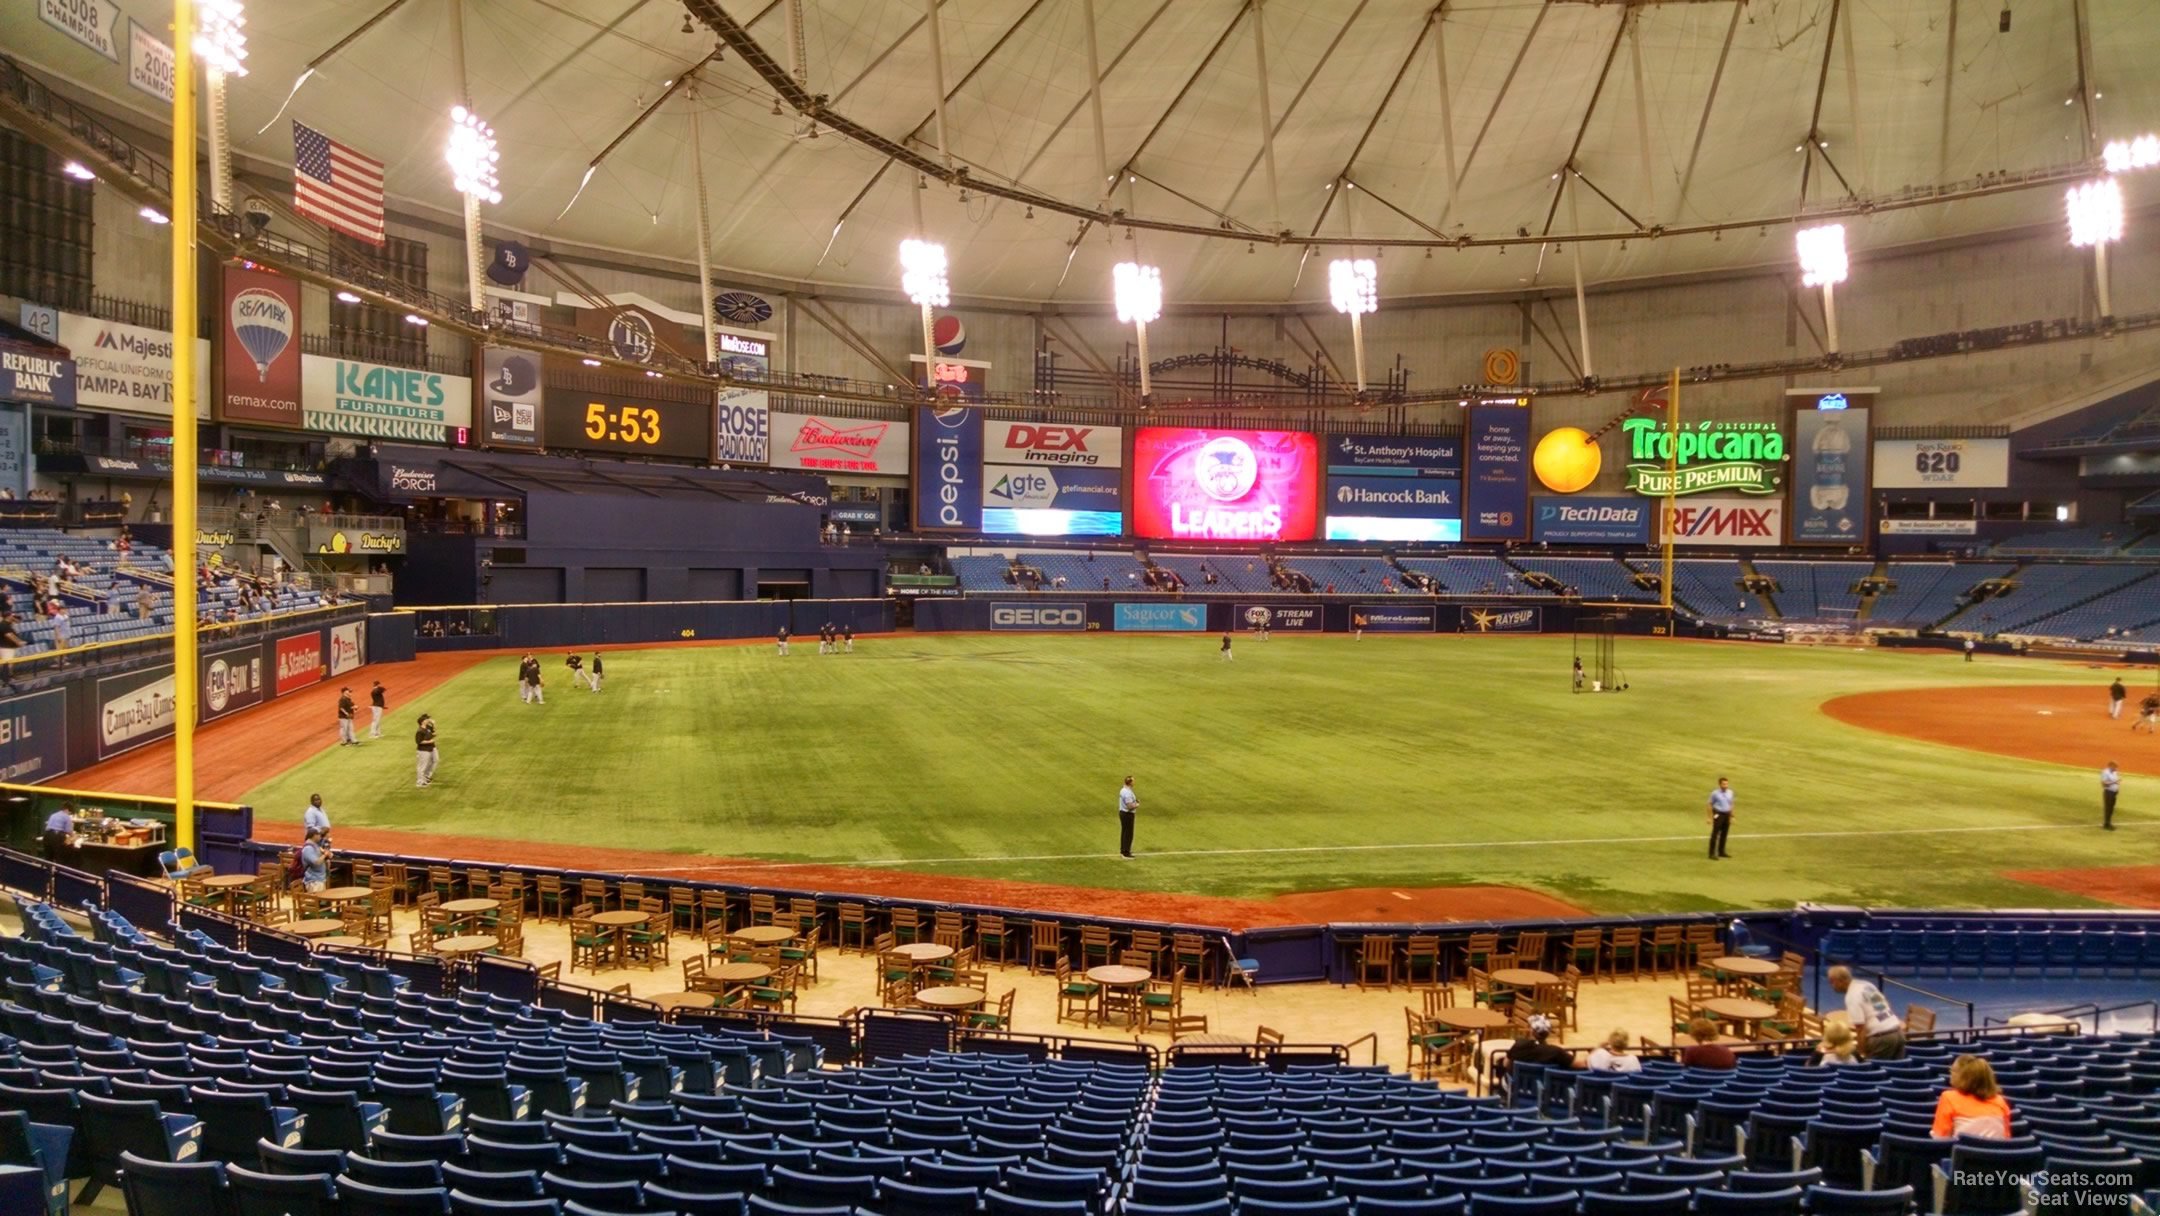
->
xmin=406 ymin=600 xmax=894 ymax=650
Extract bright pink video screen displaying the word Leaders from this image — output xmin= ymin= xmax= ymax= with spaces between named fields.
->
xmin=1132 ymin=425 xmax=1320 ymax=542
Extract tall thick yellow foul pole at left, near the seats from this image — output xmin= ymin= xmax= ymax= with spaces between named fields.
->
xmin=171 ymin=0 xmax=201 ymax=849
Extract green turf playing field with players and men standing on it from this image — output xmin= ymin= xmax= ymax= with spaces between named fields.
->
xmin=248 ymin=635 xmax=2147 ymax=911
